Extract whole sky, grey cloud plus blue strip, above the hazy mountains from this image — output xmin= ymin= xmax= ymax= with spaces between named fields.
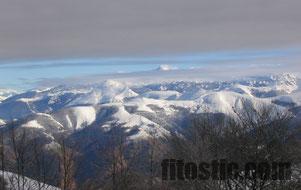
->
xmin=0 ymin=0 xmax=301 ymax=88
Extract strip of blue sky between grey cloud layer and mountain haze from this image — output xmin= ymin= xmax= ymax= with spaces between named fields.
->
xmin=0 ymin=48 xmax=301 ymax=90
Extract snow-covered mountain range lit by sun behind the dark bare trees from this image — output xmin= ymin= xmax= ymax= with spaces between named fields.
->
xmin=0 ymin=74 xmax=301 ymax=138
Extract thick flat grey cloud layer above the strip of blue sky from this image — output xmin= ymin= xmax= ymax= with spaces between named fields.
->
xmin=0 ymin=0 xmax=301 ymax=59
